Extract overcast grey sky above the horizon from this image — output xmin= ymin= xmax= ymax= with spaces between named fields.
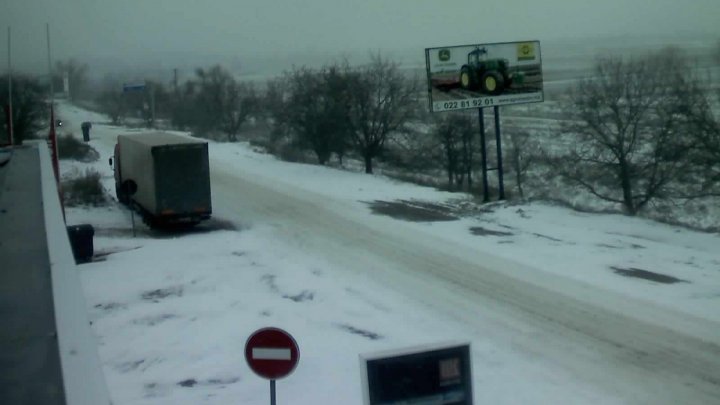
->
xmin=0 ymin=0 xmax=720 ymax=76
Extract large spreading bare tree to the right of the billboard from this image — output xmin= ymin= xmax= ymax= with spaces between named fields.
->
xmin=555 ymin=49 xmax=697 ymax=215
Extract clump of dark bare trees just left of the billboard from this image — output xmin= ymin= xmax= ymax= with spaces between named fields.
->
xmin=267 ymin=55 xmax=418 ymax=173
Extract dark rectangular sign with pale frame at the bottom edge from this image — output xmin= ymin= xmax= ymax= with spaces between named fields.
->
xmin=361 ymin=343 xmax=473 ymax=405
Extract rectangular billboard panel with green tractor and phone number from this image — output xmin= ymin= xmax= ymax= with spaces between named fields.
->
xmin=425 ymin=41 xmax=543 ymax=112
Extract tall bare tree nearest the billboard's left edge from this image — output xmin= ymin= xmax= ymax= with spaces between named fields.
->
xmin=346 ymin=55 xmax=418 ymax=173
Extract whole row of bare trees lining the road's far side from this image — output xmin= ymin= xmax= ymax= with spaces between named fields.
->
xmin=87 ymin=49 xmax=720 ymax=215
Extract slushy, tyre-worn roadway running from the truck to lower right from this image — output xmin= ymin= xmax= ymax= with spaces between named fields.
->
xmin=212 ymin=163 xmax=720 ymax=404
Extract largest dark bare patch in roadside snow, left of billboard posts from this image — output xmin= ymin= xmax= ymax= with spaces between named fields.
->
xmin=368 ymin=200 xmax=459 ymax=222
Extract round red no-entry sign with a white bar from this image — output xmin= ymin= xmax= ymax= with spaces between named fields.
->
xmin=245 ymin=328 xmax=300 ymax=380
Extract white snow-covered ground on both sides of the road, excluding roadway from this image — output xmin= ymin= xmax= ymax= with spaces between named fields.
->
xmin=54 ymin=104 xmax=720 ymax=404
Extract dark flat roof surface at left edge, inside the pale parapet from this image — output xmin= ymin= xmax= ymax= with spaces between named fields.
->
xmin=0 ymin=145 xmax=65 ymax=405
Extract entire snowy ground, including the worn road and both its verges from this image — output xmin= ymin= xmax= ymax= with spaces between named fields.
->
xmin=56 ymin=100 xmax=720 ymax=404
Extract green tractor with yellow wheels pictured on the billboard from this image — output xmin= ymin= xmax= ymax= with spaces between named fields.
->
xmin=460 ymin=48 xmax=522 ymax=96
